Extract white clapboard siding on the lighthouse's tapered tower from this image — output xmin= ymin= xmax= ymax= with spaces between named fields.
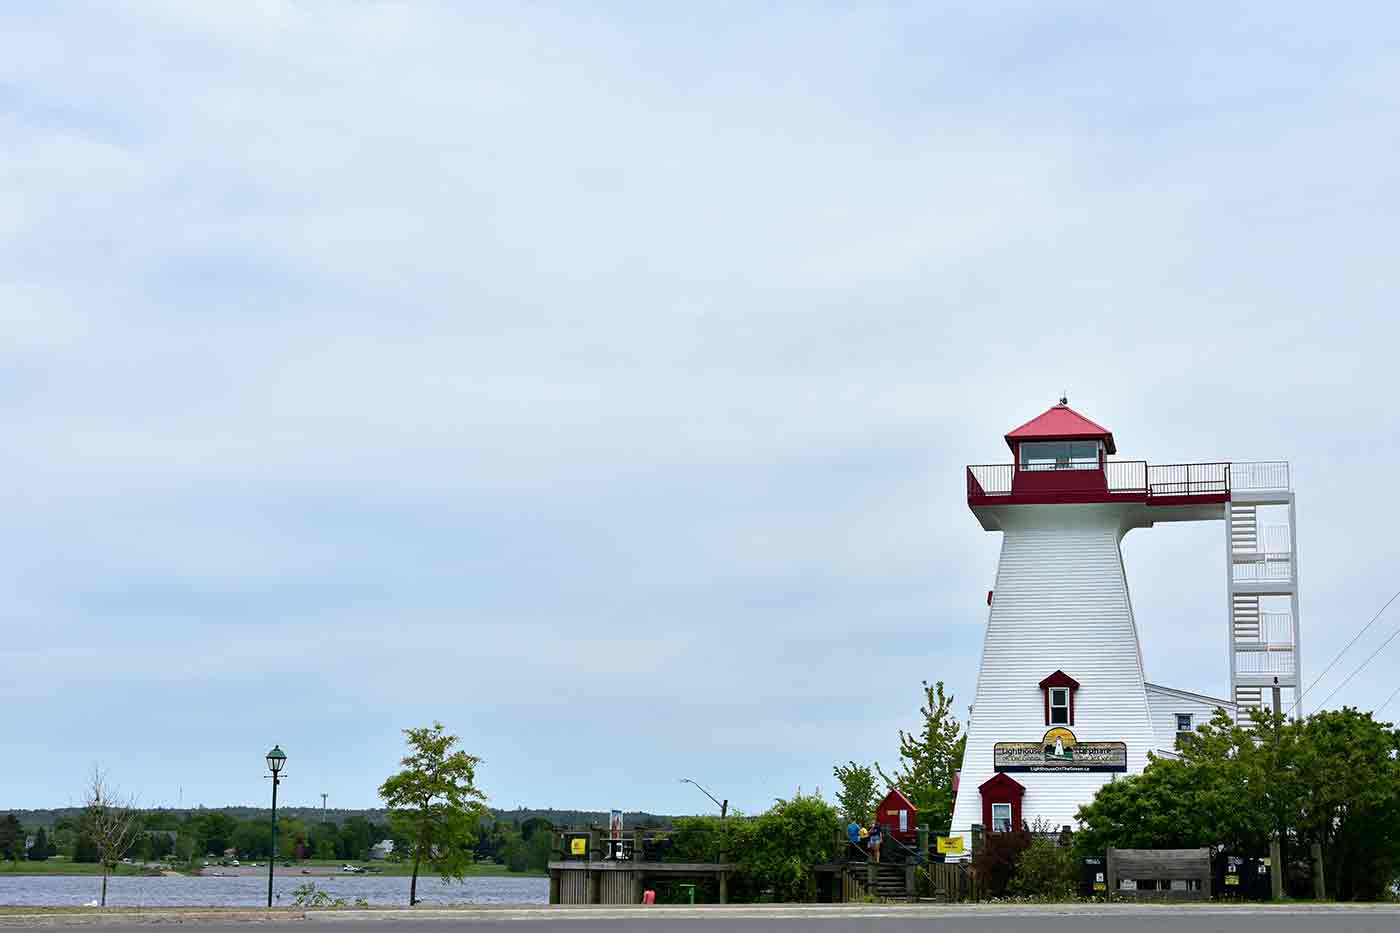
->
xmin=952 ymin=504 xmax=1156 ymax=843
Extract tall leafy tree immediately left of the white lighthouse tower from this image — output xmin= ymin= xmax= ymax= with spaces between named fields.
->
xmin=875 ymin=681 xmax=967 ymax=829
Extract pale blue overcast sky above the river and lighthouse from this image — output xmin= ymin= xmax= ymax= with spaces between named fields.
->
xmin=0 ymin=0 xmax=1400 ymax=813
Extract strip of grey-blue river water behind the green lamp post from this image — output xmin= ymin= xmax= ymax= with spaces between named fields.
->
xmin=0 ymin=874 xmax=549 ymax=906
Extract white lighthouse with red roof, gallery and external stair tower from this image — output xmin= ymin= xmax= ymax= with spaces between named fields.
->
xmin=951 ymin=399 xmax=1298 ymax=843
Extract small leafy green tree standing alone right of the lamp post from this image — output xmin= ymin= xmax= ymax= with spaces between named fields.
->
xmin=379 ymin=723 xmax=486 ymax=906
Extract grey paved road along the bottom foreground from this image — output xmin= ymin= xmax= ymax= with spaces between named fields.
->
xmin=6 ymin=905 xmax=1400 ymax=933
